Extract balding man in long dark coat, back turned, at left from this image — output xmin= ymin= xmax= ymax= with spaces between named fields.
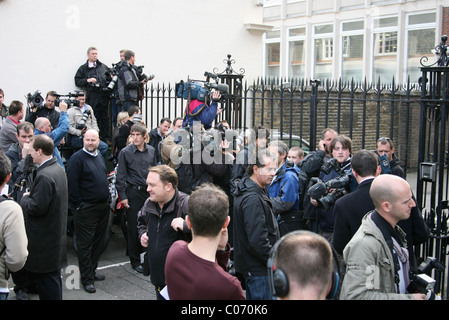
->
xmin=20 ymin=134 xmax=68 ymax=300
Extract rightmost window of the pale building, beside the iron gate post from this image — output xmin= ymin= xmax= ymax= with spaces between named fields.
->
xmin=406 ymin=12 xmax=436 ymax=83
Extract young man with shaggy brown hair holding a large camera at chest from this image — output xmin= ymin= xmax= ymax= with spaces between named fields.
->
xmin=309 ymin=135 xmax=356 ymax=243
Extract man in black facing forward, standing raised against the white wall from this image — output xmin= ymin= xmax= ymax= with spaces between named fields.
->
xmin=75 ymin=47 xmax=110 ymax=146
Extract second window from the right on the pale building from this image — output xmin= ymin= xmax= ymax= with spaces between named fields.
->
xmin=373 ymin=17 xmax=398 ymax=83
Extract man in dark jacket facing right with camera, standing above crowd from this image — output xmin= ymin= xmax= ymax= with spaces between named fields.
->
xmin=118 ymin=50 xmax=149 ymax=111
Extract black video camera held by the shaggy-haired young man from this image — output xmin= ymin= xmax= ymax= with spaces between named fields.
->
xmin=307 ymin=174 xmax=351 ymax=210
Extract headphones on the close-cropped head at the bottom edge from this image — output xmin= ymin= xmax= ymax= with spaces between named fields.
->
xmin=267 ymin=230 xmax=340 ymax=300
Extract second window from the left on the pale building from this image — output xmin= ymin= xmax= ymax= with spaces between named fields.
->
xmin=288 ymin=28 xmax=306 ymax=78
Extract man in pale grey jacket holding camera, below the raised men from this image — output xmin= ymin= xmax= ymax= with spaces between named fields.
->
xmin=67 ymin=91 xmax=108 ymax=158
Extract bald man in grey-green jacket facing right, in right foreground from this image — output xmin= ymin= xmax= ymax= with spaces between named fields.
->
xmin=340 ymin=174 xmax=426 ymax=300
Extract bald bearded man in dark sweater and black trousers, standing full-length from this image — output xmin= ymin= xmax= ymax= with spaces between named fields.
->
xmin=67 ymin=129 xmax=109 ymax=293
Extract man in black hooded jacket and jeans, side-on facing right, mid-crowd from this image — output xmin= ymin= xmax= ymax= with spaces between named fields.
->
xmin=234 ymin=149 xmax=279 ymax=300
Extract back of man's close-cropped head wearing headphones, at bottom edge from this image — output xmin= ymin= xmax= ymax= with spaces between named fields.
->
xmin=267 ymin=230 xmax=339 ymax=300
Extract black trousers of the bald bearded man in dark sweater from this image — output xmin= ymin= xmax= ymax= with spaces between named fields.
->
xmin=74 ymin=201 xmax=109 ymax=285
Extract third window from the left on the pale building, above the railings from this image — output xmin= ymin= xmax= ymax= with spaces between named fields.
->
xmin=313 ymin=24 xmax=334 ymax=80
